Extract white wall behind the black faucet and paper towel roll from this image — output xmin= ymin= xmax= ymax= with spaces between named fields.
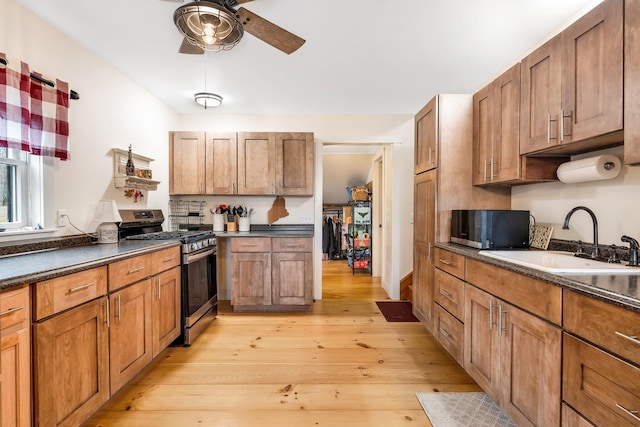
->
xmin=511 ymin=147 xmax=640 ymax=246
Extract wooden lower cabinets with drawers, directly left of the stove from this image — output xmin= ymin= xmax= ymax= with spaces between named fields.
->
xmin=32 ymin=246 xmax=180 ymax=426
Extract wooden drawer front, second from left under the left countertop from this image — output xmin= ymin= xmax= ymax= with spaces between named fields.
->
xmin=33 ymin=267 xmax=107 ymax=320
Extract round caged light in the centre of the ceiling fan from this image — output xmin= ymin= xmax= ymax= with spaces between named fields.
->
xmin=173 ymin=0 xmax=244 ymax=51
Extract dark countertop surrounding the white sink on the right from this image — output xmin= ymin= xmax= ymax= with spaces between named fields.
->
xmin=435 ymin=243 xmax=640 ymax=313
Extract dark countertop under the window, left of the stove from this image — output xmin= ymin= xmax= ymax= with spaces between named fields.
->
xmin=0 ymin=240 xmax=180 ymax=290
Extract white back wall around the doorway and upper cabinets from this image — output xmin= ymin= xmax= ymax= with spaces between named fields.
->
xmin=178 ymin=112 xmax=414 ymax=299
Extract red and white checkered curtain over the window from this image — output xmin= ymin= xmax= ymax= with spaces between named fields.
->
xmin=0 ymin=53 xmax=69 ymax=160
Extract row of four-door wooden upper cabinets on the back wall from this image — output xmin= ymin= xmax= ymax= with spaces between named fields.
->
xmin=169 ymin=132 xmax=314 ymax=196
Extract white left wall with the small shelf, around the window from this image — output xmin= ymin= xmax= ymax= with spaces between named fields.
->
xmin=0 ymin=0 xmax=179 ymax=240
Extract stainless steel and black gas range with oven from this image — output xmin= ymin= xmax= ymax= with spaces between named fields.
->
xmin=118 ymin=209 xmax=218 ymax=346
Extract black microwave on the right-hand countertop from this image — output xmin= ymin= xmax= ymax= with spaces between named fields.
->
xmin=451 ymin=210 xmax=530 ymax=249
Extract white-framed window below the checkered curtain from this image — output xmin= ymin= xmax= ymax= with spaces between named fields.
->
xmin=0 ymin=148 xmax=42 ymax=230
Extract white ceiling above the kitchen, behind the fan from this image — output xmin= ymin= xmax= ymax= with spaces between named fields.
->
xmin=17 ymin=0 xmax=598 ymax=114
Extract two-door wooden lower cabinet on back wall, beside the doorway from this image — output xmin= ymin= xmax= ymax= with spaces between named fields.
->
xmin=231 ymin=237 xmax=313 ymax=311
